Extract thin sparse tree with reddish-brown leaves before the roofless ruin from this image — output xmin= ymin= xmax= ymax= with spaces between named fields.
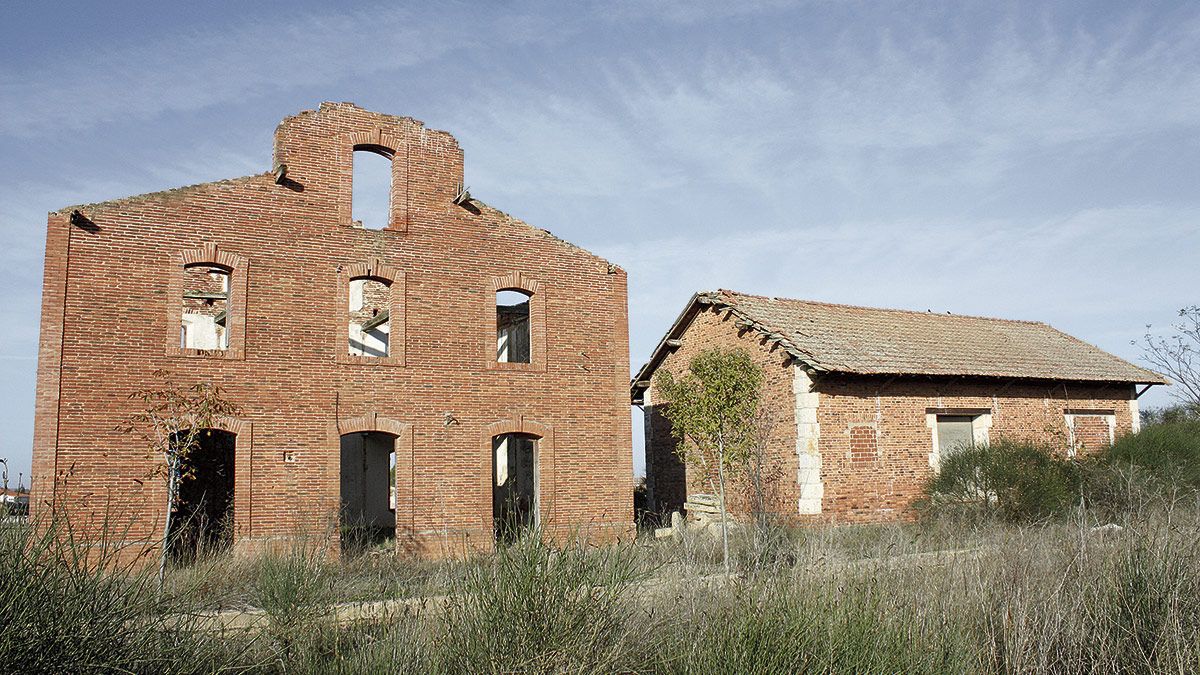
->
xmin=119 ymin=370 xmax=240 ymax=591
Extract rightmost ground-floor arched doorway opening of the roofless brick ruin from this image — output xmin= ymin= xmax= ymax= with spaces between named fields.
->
xmin=492 ymin=434 xmax=539 ymax=542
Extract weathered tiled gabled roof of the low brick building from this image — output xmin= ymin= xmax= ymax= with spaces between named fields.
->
xmin=632 ymin=289 xmax=1166 ymax=399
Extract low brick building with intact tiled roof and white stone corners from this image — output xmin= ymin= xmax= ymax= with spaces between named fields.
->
xmin=631 ymin=291 xmax=1165 ymax=521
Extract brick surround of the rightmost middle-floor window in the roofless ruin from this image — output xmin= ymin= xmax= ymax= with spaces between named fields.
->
xmin=481 ymin=271 xmax=547 ymax=372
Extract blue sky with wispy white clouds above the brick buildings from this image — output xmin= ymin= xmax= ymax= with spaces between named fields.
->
xmin=0 ymin=0 xmax=1200 ymax=477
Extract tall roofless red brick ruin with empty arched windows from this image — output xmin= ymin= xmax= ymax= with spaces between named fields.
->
xmin=34 ymin=103 xmax=632 ymax=555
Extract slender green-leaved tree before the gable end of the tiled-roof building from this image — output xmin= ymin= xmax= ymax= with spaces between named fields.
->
xmin=654 ymin=348 xmax=762 ymax=577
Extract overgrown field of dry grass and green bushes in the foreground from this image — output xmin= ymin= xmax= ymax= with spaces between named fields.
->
xmin=0 ymin=424 xmax=1200 ymax=673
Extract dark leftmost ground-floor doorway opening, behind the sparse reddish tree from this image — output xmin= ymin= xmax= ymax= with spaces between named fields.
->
xmin=168 ymin=429 xmax=238 ymax=565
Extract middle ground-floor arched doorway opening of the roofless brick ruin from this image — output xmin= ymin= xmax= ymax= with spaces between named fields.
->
xmin=341 ymin=431 xmax=396 ymax=552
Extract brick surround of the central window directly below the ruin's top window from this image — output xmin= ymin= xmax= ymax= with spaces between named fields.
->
xmin=334 ymin=258 xmax=406 ymax=366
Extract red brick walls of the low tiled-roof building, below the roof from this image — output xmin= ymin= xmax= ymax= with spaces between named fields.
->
xmin=643 ymin=307 xmax=1138 ymax=522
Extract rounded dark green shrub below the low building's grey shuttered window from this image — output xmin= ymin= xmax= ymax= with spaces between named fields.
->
xmin=925 ymin=441 xmax=1082 ymax=522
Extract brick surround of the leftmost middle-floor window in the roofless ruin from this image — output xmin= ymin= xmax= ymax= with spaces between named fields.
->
xmin=167 ymin=243 xmax=250 ymax=359
